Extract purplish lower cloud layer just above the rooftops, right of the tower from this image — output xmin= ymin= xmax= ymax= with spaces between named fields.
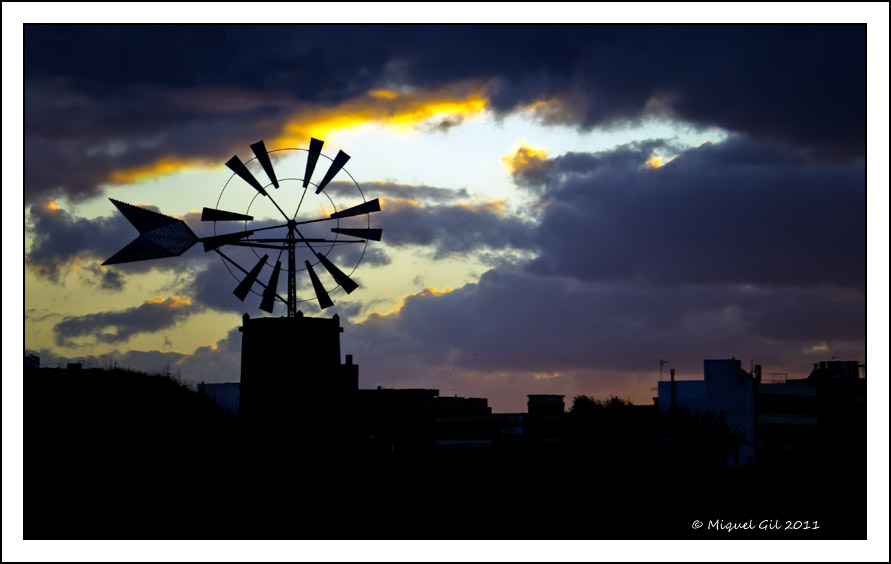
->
xmin=343 ymin=268 xmax=865 ymax=410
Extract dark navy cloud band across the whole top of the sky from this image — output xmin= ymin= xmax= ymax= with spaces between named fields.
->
xmin=24 ymin=25 xmax=866 ymax=207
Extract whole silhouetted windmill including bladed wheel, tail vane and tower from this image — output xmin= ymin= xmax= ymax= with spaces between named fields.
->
xmin=103 ymin=139 xmax=381 ymax=436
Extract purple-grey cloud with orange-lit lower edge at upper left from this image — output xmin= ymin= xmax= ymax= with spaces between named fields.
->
xmin=25 ymin=73 xmax=485 ymax=203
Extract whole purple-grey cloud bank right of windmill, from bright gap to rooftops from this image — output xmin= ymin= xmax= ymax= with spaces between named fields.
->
xmin=332 ymin=135 xmax=866 ymax=409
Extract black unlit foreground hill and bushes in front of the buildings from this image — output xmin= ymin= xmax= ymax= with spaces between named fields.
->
xmin=24 ymin=370 xmax=866 ymax=539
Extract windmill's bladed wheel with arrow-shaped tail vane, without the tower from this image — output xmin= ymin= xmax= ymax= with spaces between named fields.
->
xmin=103 ymin=135 xmax=381 ymax=317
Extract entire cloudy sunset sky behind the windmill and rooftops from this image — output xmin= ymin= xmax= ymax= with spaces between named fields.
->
xmin=13 ymin=18 xmax=887 ymax=411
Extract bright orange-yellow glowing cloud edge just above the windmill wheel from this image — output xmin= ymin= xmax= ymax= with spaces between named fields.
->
xmin=272 ymin=86 xmax=487 ymax=147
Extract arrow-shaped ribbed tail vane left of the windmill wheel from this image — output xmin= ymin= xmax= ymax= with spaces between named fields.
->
xmin=102 ymin=198 xmax=199 ymax=266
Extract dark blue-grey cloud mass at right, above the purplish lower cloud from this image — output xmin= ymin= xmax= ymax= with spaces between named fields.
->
xmin=518 ymin=134 xmax=866 ymax=289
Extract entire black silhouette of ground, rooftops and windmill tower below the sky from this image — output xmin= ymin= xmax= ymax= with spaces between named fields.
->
xmin=25 ymin=316 xmax=867 ymax=539
